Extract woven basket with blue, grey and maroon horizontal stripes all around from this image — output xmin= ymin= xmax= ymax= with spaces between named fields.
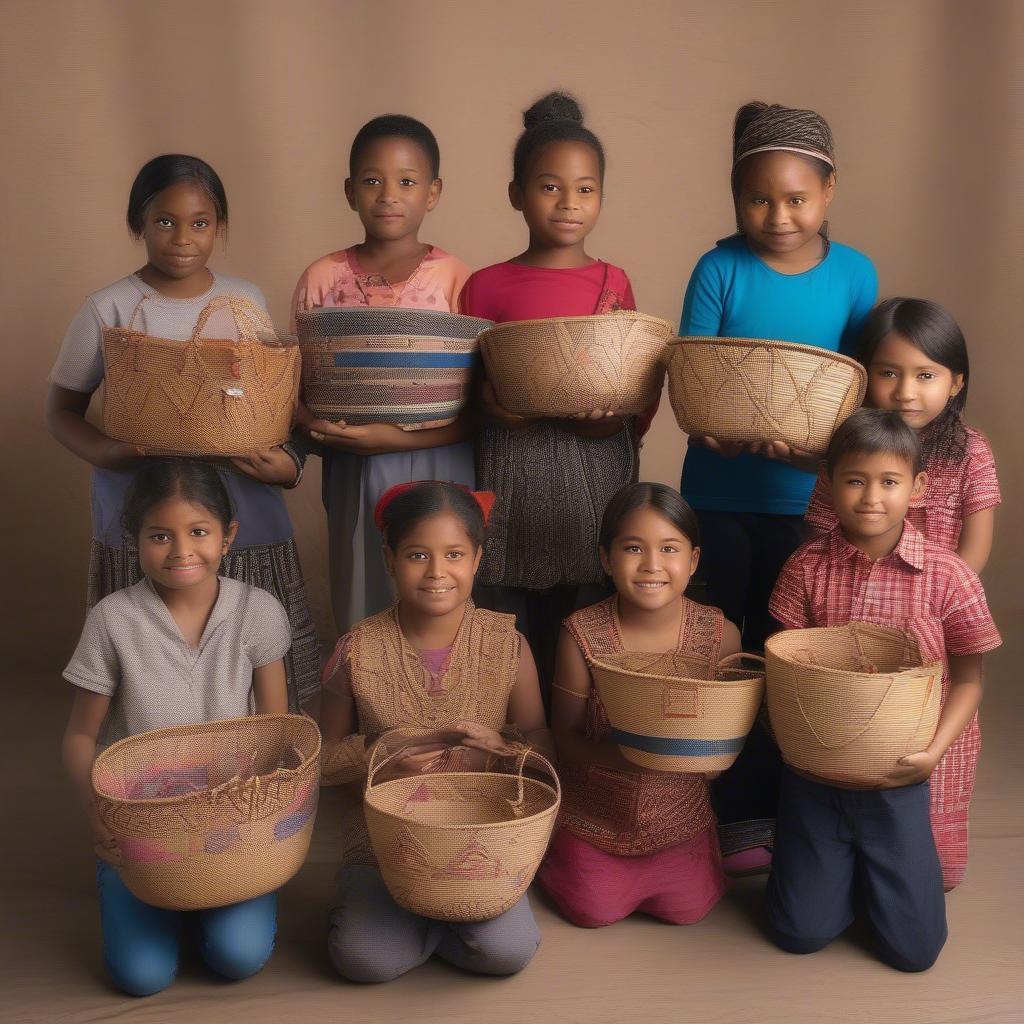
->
xmin=296 ymin=307 xmax=490 ymax=430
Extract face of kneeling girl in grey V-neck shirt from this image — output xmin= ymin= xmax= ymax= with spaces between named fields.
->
xmin=138 ymin=496 xmax=239 ymax=590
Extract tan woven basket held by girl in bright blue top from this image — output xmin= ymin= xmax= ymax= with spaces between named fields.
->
xmin=669 ymin=338 xmax=867 ymax=455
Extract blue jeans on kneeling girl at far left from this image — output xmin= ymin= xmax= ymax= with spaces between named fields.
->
xmin=96 ymin=861 xmax=278 ymax=995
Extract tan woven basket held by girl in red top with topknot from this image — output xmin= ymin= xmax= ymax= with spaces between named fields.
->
xmin=480 ymin=311 xmax=673 ymax=419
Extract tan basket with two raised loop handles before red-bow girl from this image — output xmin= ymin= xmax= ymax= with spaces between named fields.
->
xmin=364 ymin=743 xmax=561 ymax=921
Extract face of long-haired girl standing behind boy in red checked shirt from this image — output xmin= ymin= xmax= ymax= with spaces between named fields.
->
xmin=867 ymin=331 xmax=964 ymax=430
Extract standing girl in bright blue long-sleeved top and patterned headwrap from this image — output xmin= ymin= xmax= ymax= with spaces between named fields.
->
xmin=679 ymin=102 xmax=878 ymax=873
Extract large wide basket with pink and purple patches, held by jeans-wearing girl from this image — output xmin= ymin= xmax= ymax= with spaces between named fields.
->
xmin=92 ymin=715 xmax=321 ymax=910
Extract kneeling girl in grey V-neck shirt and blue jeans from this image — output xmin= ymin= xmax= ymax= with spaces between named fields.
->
xmin=63 ymin=460 xmax=291 ymax=995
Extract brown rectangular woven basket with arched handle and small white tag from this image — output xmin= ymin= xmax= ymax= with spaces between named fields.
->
xmin=103 ymin=295 xmax=299 ymax=456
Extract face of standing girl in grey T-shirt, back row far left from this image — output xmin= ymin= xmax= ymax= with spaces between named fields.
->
xmin=142 ymin=181 xmax=217 ymax=281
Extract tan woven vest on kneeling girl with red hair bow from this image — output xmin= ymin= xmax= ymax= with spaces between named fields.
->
xmin=342 ymin=601 xmax=519 ymax=863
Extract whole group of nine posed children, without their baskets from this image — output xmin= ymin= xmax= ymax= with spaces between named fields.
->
xmin=47 ymin=93 xmax=999 ymax=994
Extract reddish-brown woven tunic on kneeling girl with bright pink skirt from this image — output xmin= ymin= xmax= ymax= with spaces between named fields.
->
xmin=560 ymin=596 xmax=724 ymax=857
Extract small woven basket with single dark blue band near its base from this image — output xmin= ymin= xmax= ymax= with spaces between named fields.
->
xmin=590 ymin=651 xmax=765 ymax=772
